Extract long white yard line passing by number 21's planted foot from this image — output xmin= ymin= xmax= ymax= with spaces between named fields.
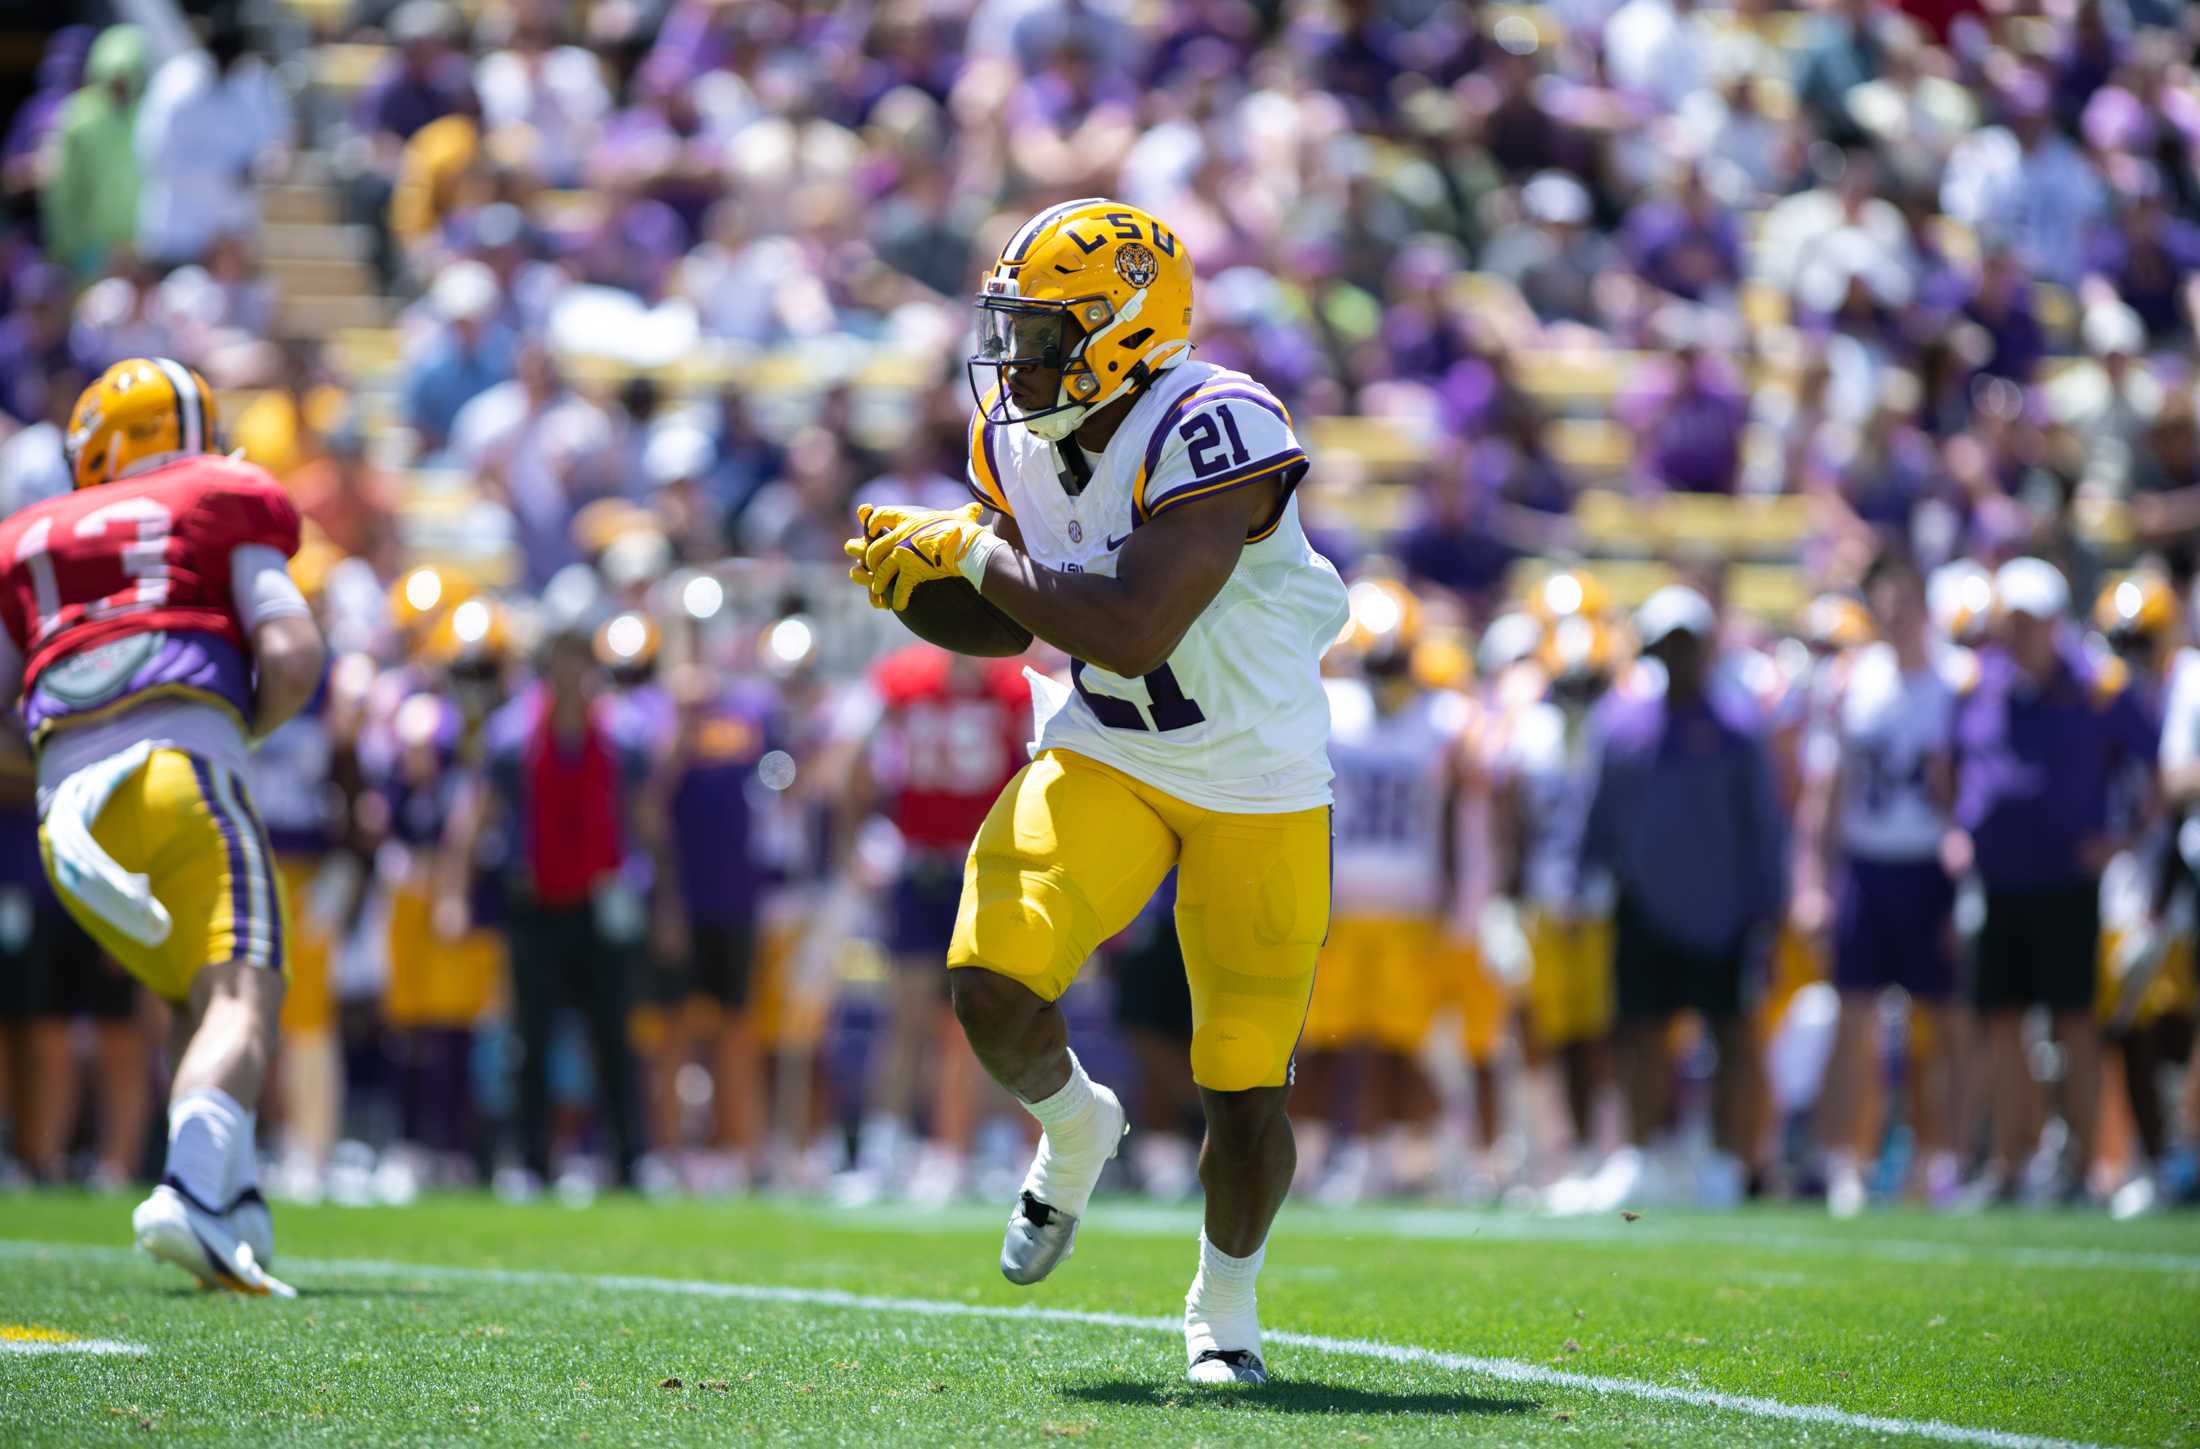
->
xmin=0 ymin=1242 xmax=2129 ymax=1449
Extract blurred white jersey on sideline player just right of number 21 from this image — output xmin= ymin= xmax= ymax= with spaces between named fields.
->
xmin=1329 ymin=679 xmax=1470 ymax=917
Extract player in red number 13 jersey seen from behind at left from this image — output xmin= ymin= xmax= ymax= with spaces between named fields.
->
xmin=0 ymin=358 xmax=326 ymax=1297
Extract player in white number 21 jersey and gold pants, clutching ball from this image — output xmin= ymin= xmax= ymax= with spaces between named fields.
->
xmin=849 ymin=198 xmax=1346 ymax=1383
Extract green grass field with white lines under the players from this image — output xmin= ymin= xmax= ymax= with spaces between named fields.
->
xmin=0 ymin=1196 xmax=2200 ymax=1449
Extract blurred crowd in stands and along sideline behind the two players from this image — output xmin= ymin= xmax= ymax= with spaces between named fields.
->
xmin=0 ymin=0 xmax=2200 ymax=1212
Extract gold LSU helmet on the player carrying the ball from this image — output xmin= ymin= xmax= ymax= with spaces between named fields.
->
xmin=968 ymin=196 xmax=1192 ymax=442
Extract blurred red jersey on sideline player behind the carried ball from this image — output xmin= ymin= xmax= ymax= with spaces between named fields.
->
xmin=871 ymin=644 xmax=1032 ymax=851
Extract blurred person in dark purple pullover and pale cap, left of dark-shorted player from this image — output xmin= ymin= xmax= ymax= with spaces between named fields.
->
xmin=1580 ymin=585 xmax=1789 ymax=1209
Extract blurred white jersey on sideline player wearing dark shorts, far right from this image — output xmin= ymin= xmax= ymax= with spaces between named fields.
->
xmin=1837 ymin=644 xmax=1956 ymax=862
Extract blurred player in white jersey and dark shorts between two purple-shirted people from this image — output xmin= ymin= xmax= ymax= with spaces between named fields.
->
xmin=1802 ymin=554 xmax=1958 ymax=1216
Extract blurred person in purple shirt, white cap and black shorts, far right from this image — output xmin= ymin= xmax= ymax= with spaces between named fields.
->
xmin=1951 ymin=558 xmax=2158 ymax=1198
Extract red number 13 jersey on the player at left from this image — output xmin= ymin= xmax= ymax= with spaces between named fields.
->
xmin=0 ymin=455 xmax=299 ymax=730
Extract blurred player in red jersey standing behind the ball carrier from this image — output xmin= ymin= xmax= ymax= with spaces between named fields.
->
xmin=843 ymin=644 xmax=1032 ymax=1201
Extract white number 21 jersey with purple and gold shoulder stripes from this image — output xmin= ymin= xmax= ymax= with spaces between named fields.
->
xmin=970 ymin=361 xmax=1346 ymax=814
